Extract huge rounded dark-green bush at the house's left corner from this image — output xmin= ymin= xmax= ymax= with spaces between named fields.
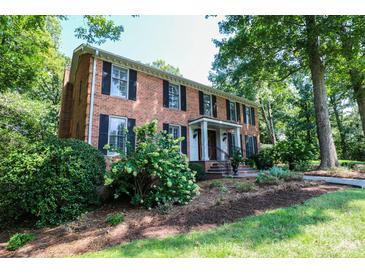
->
xmin=0 ymin=138 xmax=105 ymax=225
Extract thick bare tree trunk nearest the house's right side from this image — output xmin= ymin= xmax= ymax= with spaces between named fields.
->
xmin=305 ymin=15 xmax=338 ymax=169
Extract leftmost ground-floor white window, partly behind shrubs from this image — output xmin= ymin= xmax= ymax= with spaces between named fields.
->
xmin=107 ymin=116 xmax=127 ymax=156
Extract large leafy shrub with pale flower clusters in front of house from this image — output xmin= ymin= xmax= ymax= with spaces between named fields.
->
xmin=106 ymin=121 xmax=198 ymax=208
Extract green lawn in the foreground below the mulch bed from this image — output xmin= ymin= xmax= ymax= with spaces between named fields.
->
xmin=83 ymin=189 xmax=365 ymax=257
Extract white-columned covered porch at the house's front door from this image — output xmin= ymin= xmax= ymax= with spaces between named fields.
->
xmin=189 ymin=117 xmax=242 ymax=161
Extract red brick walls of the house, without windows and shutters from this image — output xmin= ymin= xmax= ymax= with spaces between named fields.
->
xmin=68 ymin=55 xmax=259 ymax=156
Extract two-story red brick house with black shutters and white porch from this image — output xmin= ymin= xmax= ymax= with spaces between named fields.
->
xmin=59 ymin=45 xmax=259 ymax=168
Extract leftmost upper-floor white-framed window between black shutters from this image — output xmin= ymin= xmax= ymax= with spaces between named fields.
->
xmin=110 ymin=65 xmax=129 ymax=99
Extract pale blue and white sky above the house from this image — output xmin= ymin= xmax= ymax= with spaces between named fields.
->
xmin=61 ymin=16 xmax=222 ymax=85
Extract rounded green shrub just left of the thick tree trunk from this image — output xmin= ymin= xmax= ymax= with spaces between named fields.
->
xmin=275 ymin=139 xmax=314 ymax=170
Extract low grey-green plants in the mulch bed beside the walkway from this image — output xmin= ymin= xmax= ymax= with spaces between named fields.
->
xmin=256 ymin=167 xmax=303 ymax=185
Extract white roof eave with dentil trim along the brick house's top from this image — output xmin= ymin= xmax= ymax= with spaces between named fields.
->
xmin=70 ymin=44 xmax=258 ymax=107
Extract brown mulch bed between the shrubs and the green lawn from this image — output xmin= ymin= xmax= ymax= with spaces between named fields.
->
xmin=0 ymin=182 xmax=346 ymax=257
